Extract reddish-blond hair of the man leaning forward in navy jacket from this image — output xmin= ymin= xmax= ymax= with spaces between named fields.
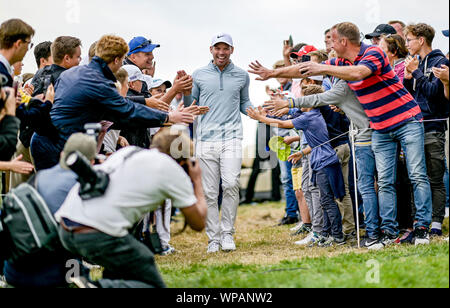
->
xmin=95 ymin=35 xmax=129 ymax=64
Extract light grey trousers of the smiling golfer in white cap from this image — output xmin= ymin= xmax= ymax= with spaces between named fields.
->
xmin=196 ymin=139 xmax=242 ymax=243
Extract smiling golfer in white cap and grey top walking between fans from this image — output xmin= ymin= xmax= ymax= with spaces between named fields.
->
xmin=185 ymin=33 xmax=253 ymax=253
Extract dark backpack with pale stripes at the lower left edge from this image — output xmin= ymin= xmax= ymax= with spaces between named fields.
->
xmin=0 ymin=176 xmax=60 ymax=261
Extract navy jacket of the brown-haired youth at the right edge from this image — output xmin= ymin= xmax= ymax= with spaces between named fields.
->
xmin=404 ymin=50 xmax=450 ymax=132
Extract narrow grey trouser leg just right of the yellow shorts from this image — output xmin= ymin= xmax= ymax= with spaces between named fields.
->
xmin=302 ymin=155 xmax=323 ymax=233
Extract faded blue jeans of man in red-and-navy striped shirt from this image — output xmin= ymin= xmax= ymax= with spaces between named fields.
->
xmin=372 ymin=122 xmax=432 ymax=235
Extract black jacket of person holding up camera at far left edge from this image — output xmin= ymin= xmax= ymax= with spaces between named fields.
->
xmin=0 ymin=115 xmax=20 ymax=161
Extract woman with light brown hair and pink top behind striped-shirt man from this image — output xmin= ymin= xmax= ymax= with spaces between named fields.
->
xmin=380 ymin=34 xmax=408 ymax=83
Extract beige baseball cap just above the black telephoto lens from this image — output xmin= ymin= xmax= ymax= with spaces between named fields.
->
xmin=59 ymin=133 xmax=97 ymax=170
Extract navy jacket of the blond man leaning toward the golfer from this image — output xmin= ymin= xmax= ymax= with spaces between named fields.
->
xmin=50 ymin=57 xmax=168 ymax=140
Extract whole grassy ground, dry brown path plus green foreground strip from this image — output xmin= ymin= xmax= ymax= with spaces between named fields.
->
xmin=157 ymin=203 xmax=449 ymax=288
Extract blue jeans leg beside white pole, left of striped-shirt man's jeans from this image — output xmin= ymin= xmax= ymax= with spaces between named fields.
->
xmin=355 ymin=144 xmax=380 ymax=238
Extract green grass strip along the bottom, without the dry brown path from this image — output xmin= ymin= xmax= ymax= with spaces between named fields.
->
xmin=160 ymin=243 xmax=449 ymax=288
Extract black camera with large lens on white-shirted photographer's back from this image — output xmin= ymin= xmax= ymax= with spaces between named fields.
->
xmin=66 ymin=151 xmax=110 ymax=201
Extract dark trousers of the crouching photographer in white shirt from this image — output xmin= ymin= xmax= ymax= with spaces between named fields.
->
xmin=59 ymin=227 xmax=166 ymax=288
